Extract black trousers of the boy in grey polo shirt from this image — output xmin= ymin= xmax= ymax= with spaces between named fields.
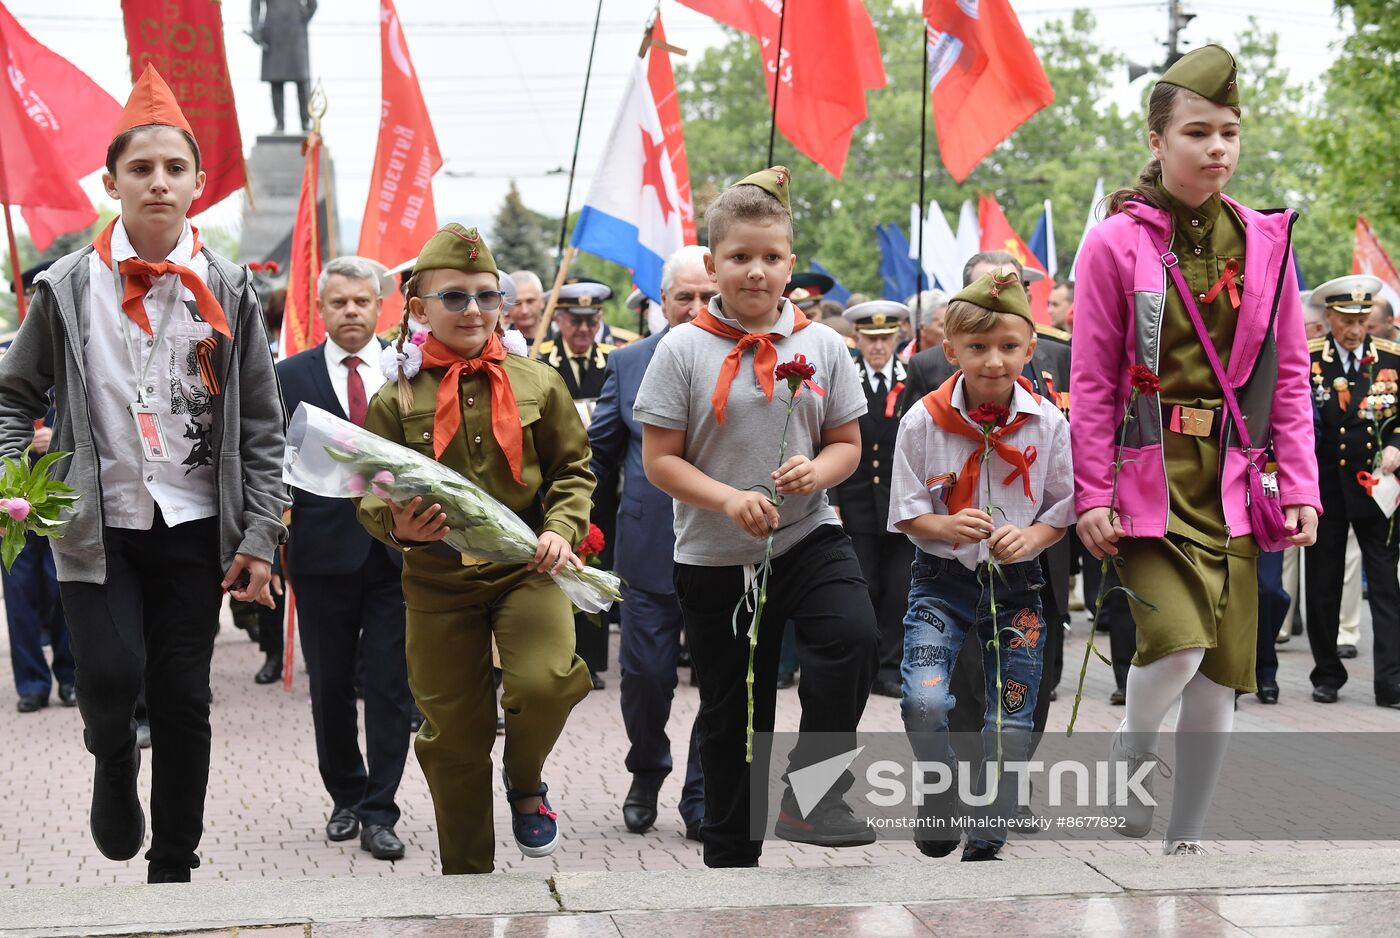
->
xmin=675 ymin=525 xmax=879 ymax=867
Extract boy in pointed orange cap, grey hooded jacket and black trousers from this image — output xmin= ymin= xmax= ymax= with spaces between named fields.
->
xmin=0 ymin=66 xmax=288 ymax=882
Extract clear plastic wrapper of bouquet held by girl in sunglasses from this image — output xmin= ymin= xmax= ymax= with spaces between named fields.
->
xmin=281 ymin=403 xmax=622 ymax=612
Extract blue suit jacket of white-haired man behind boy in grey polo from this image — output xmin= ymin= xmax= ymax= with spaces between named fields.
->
xmin=588 ymin=330 xmax=676 ymax=594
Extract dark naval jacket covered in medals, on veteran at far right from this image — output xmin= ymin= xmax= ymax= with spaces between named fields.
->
xmin=1308 ymin=335 xmax=1400 ymax=521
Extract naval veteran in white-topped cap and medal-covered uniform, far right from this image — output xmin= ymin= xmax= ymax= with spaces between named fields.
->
xmin=1303 ymin=274 xmax=1400 ymax=708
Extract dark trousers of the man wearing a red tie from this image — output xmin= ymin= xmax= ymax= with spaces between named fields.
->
xmin=293 ymin=545 xmax=413 ymax=827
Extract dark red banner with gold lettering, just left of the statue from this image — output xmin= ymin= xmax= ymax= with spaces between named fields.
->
xmin=121 ymin=0 xmax=248 ymax=216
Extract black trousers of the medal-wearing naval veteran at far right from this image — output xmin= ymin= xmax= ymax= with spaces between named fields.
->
xmin=1305 ymin=505 xmax=1400 ymax=697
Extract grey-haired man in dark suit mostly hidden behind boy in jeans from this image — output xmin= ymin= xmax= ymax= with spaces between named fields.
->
xmin=904 ymin=251 xmax=1070 ymax=734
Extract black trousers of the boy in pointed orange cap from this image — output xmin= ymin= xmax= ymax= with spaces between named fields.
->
xmin=59 ymin=510 xmax=224 ymax=869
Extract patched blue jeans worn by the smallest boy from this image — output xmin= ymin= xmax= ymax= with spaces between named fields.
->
xmin=900 ymin=550 xmax=1044 ymax=847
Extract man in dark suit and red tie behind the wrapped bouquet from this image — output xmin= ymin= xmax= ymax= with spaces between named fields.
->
xmin=277 ymin=258 xmax=413 ymax=860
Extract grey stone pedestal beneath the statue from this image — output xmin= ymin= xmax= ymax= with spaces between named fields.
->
xmin=239 ymin=134 xmax=347 ymax=264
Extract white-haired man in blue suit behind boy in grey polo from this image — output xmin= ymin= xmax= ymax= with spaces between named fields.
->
xmin=588 ymin=246 xmax=715 ymax=840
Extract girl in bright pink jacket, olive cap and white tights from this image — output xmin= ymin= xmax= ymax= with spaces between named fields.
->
xmin=1070 ymin=45 xmax=1320 ymax=854
